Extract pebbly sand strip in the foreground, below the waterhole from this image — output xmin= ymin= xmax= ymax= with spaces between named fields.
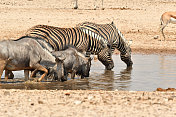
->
xmin=0 ymin=89 xmax=176 ymax=117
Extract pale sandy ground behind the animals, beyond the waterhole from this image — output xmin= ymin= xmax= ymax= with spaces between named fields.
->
xmin=0 ymin=0 xmax=176 ymax=53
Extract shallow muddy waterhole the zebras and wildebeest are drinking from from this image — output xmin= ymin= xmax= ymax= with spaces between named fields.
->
xmin=0 ymin=54 xmax=176 ymax=91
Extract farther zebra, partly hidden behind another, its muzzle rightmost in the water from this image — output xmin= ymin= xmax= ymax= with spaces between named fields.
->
xmin=77 ymin=22 xmax=133 ymax=67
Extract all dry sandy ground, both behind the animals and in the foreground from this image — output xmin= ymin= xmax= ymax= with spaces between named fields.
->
xmin=0 ymin=0 xmax=176 ymax=117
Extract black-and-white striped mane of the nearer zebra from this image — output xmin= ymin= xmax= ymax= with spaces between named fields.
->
xmin=80 ymin=27 xmax=109 ymax=47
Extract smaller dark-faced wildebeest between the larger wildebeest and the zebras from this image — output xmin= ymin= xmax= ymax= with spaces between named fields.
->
xmin=52 ymin=46 xmax=91 ymax=80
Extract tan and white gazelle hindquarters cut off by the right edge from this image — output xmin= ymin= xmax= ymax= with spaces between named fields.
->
xmin=160 ymin=12 xmax=176 ymax=40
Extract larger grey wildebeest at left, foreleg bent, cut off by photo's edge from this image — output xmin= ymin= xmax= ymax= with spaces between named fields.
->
xmin=0 ymin=38 xmax=65 ymax=81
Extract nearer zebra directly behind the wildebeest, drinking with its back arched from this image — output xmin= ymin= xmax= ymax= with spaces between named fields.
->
xmin=22 ymin=25 xmax=114 ymax=70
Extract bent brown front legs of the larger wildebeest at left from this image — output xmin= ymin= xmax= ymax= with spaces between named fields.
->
xmin=31 ymin=63 xmax=48 ymax=82
